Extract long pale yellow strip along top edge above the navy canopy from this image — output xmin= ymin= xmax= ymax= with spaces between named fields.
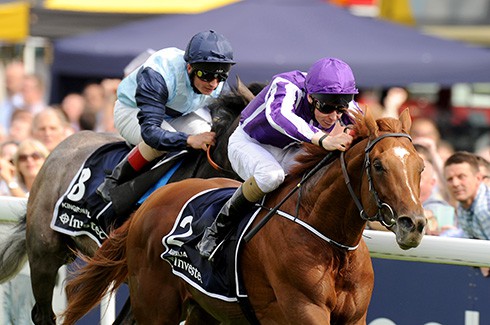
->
xmin=44 ymin=0 xmax=240 ymax=14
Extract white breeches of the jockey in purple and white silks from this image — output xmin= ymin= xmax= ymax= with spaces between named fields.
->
xmin=228 ymin=126 xmax=301 ymax=193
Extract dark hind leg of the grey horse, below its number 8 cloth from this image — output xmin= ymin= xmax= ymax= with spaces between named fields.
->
xmin=27 ymin=225 xmax=70 ymax=325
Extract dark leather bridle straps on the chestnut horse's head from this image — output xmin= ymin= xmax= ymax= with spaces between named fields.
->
xmin=340 ymin=133 xmax=412 ymax=228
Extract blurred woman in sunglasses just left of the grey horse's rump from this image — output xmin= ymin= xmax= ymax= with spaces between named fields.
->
xmin=0 ymin=139 xmax=49 ymax=197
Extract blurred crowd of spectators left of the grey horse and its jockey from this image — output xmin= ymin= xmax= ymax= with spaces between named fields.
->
xmin=0 ymin=61 xmax=120 ymax=325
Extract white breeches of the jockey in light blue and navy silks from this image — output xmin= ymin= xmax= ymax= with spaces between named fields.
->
xmin=114 ymin=100 xmax=211 ymax=145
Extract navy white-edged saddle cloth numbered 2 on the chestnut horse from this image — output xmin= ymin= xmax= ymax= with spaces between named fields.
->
xmin=161 ymin=188 xmax=259 ymax=302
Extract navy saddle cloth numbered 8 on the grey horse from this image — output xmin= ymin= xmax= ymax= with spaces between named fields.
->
xmin=51 ymin=141 xmax=181 ymax=246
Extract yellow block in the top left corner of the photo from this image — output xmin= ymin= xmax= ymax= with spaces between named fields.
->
xmin=0 ymin=2 xmax=29 ymax=42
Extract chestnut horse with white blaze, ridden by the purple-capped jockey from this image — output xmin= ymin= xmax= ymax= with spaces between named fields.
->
xmin=64 ymin=110 xmax=426 ymax=324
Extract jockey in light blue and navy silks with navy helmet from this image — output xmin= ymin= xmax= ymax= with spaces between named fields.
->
xmin=97 ymin=30 xmax=235 ymax=201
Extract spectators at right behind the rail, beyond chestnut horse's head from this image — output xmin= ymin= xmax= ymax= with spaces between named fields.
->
xmin=359 ymin=87 xmax=490 ymax=243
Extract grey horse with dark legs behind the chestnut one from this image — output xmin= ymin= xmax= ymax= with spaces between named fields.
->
xmin=0 ymin=80 xmax=253 ymax=325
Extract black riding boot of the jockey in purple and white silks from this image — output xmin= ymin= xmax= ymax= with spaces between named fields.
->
xmin=197 ymin=186 xmax=254 ymax=258
